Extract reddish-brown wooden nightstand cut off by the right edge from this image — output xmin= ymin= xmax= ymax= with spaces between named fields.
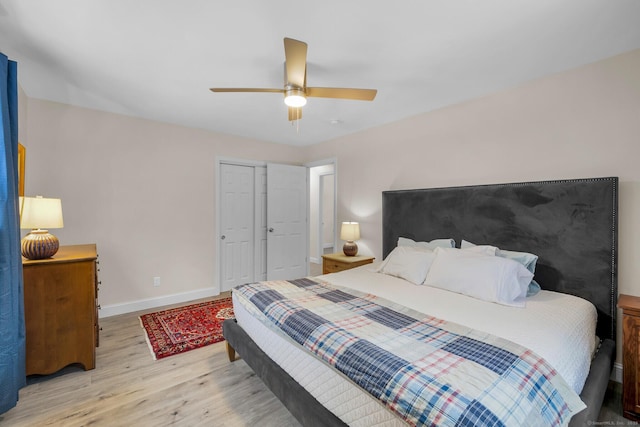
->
xmin=618 ymin=295 xmax=640 ymax=421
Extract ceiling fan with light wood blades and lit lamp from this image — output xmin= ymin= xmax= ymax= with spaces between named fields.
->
xmin=211 ymin=37 xmax=378 ymax=121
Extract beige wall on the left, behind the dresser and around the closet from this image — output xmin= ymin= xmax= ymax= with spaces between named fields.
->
xmin=25 ymin=99 xmax=301 ymax=315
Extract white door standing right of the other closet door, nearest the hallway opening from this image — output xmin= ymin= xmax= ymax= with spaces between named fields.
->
xmin=267 ymin=164 xmax=309 ymax=280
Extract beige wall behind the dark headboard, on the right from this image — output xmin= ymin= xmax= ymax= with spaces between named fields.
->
xmin=307 ymin=50 xmax=640 ymax=364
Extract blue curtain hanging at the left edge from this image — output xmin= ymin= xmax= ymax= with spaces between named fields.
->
xmin=0 ymin=53 xmax=26 ymax=414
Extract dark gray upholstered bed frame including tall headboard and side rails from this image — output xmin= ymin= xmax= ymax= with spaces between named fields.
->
xmin=223 ymin=177 xmax=618 ymax=426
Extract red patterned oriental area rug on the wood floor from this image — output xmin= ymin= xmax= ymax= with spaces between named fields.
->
xmin=140 ymin=297 xmax=234 ymax=360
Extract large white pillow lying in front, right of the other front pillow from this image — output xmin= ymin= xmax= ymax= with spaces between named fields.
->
xmin=425 ymin=248 xmax=533 ymax=307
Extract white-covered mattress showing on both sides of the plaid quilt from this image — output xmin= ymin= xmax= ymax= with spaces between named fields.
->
xmin=233 ymin=265 xmax=597 ymax=426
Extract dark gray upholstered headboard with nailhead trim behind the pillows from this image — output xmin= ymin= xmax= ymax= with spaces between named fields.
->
xmin=382 ymin=177 xmax=618 ymax=341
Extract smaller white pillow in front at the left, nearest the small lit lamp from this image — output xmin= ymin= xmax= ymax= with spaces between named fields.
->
xmin=378 ymin=246 xmax=436 ymax=285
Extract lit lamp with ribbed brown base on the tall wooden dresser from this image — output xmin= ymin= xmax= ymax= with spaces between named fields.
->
xmin=20 ymin=196 xmax=64 ymax=259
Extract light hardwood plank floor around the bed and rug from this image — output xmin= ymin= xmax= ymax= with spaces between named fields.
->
xmin=0 ymin=290 xmax=630 ymax=427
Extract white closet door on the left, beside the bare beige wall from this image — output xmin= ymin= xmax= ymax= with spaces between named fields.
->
xmin=219 ymin=164 xmax=255 ymax=291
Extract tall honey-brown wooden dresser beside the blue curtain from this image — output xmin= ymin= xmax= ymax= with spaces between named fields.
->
xmin=22 ymin=244 xmax=98 ymax=375
